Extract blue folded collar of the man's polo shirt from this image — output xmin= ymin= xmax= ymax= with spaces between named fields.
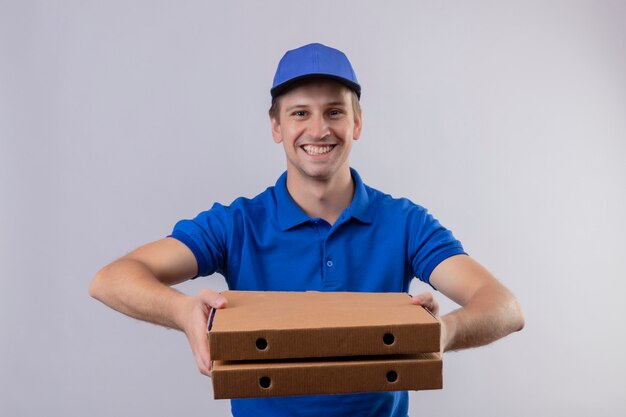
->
xmin=274 ymin=168 xmax=372 ymax=232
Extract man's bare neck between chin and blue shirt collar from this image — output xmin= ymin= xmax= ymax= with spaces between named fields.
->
xmin=287 ymin=168 xmax=354 ymax=225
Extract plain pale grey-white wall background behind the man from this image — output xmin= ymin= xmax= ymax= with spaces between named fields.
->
xmin=0 ymin=0 xmax=626 ymax=417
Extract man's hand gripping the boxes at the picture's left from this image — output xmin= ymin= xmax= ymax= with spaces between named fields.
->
xmin=179 ymin=288 xmax=227 ymax=376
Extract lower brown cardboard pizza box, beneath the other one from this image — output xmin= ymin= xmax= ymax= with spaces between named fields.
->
xmin=212 ymin=353 xmax=442 ymax=399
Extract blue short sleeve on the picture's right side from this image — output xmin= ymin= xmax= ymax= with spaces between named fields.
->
xmin=409 ymin=206 xmax=466 ymax=284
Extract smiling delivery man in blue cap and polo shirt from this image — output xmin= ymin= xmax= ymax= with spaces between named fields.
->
xmin=90 ymin=44 xmax=523 ymax=416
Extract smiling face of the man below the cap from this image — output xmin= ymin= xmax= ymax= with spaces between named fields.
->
xmin=271 ymin=79 xmax=361 ymax=181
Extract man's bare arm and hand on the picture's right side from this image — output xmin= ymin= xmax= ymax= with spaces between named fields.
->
xmin=412 ymin=255 xmax=524 ymax=352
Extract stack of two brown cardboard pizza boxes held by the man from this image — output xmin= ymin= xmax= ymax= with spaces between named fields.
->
xmin=208 ymin=291 xmax=442 ymax=399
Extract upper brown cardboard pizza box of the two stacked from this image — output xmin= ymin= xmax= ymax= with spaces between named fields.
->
xmin=209 ymin=291 xmax=440 ymax=360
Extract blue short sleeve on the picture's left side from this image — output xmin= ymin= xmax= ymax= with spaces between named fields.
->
xmin=168 ymin=203 xmax=229 ymax=278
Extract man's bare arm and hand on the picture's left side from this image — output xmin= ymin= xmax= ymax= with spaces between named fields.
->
xmin=89 ymin=238 xmax=226 ymax=375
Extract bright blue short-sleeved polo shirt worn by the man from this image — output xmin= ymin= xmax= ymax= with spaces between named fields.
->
xmin=170 ymin=169 xmax=464 ymax=417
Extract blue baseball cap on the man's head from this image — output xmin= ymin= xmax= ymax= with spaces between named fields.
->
xmin=270 ymin=43 xmax=361 ymax=100
